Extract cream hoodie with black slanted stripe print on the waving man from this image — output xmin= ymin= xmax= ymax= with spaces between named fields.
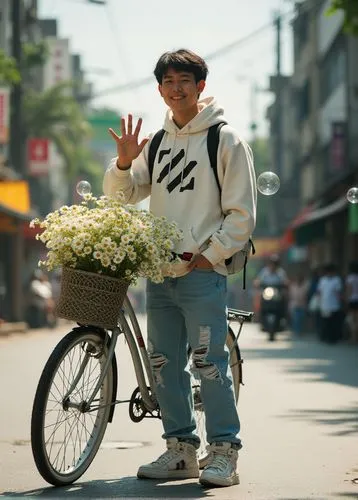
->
xmin=103 ymin=97 xmax=257 ymax=276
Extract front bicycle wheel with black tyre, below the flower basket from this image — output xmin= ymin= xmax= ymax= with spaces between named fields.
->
xmin=31 ymin=328 xmax=113 ymax=486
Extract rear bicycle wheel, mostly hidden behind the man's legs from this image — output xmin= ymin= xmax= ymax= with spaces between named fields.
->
xmin=191 ymin=327 xmax=241 ymax=469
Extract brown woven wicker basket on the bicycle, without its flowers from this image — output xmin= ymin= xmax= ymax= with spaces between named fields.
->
xmin=56 ymin=267 xmax=129 ymax=329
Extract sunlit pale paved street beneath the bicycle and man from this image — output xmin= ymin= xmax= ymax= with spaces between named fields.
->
xmin=0 ymin=318 xmax=358 ymax=500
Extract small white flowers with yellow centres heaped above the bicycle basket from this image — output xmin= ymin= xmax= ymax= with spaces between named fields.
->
xmin=30 ymin=194 xmax=182 ymax=284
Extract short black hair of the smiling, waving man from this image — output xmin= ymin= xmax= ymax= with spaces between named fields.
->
xmin=154 ymin=49 xmax=209 ymax=85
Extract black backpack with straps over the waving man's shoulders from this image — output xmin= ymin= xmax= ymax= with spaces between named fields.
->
xmin=148 ymin=122 xmax=255 ymax=289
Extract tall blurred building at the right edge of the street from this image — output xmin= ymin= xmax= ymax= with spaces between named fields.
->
xmin=268 ymin=0 xmax=358 ymax=273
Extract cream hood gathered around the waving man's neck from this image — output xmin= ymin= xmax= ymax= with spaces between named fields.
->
xmin=163 ymin=97 xmax=226 ymax=135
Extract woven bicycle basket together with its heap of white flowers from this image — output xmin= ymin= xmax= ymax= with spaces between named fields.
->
xmin=30 ymin=193 xmax=182 ymax=328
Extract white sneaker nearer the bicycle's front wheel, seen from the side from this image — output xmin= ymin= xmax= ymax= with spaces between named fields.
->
xmin=137 ymin=438 xmax=199 ymax=479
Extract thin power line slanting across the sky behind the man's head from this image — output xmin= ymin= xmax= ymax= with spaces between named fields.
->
xmin=91 ymin=11 xmax=294 ymax=99
